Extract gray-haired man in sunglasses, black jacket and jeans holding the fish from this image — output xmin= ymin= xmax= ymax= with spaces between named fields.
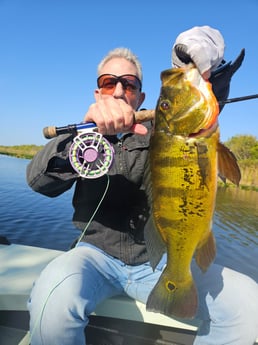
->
xmin=27 ymin=26 xmax=258 ymax=345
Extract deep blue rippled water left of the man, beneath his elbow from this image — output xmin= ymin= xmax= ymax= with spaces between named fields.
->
xmin=0 ymin=155 xmax=79 ymax=250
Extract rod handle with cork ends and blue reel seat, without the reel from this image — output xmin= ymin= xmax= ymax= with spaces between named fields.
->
xmin=43 ymin=110 xmax=155 ymax=139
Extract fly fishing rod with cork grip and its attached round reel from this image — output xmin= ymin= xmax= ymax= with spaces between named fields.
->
xmin=43 ymin=94 xmax=258 ymax=179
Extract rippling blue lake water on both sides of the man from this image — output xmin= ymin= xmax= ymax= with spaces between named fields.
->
xmin=0 ymin=155 xmax=258 ymax=282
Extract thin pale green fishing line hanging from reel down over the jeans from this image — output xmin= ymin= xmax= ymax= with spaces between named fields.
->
xmin=29 ymin=174 xmax=110 ymax=343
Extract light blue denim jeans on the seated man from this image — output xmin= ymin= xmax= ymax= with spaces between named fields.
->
xmin=28 ymin=244 xmax=258 ymax=345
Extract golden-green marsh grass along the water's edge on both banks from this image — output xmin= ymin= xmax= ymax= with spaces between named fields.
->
xmin=0 ymin=145 xmax=258 ymax=192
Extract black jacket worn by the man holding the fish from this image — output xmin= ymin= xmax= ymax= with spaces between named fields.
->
xmin=27 ymin=52 xmax=244 ymax=265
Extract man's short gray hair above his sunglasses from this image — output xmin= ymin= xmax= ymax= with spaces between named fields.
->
xmin=97 ymin=48 xmax=142 ymax=81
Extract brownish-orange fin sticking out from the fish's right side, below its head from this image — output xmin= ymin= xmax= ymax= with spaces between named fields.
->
xmin=217 ymin=143 xmax=241 ymax=186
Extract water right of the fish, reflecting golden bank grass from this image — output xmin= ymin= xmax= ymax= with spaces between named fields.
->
xmin=213 ymin=188 xmax=258 ymax=282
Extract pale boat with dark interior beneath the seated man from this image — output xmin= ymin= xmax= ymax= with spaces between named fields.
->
xmin=0 ymin=241 xmax=258 ymax=345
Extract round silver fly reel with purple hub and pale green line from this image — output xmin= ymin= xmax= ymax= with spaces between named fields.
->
xmin=69 ymin=132 xmax=114 ymax=179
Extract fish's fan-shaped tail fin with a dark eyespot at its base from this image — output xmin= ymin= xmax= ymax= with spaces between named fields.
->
xmin=146 ymin=270 xmax=198 ymax=318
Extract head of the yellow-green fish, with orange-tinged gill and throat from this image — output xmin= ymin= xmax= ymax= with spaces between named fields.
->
xmin=159 ymin=67 xmax=219 ymax=137
